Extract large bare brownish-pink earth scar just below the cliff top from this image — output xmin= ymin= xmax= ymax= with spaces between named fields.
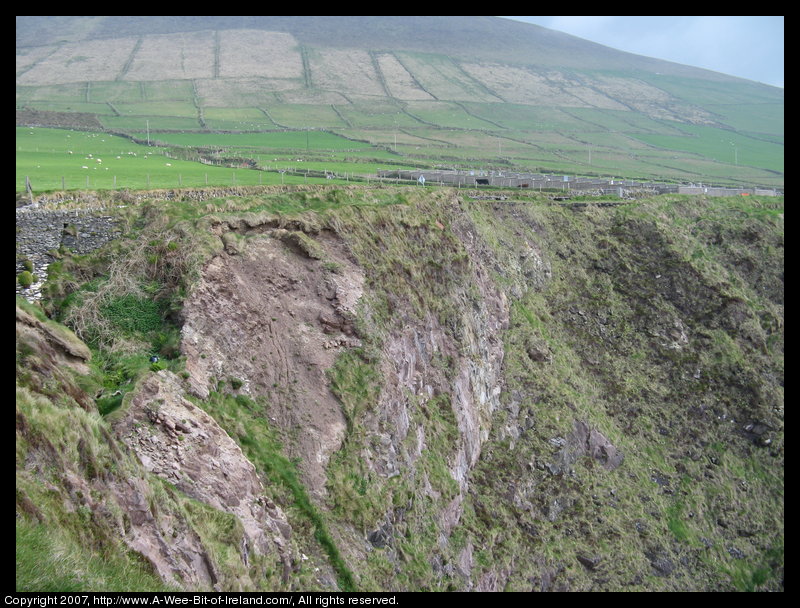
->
xmin=182 ymin=229 xmax=363 ymax=494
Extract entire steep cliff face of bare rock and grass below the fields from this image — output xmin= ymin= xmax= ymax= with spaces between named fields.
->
xmin=17 ymin=190 xmax=783 ymax=591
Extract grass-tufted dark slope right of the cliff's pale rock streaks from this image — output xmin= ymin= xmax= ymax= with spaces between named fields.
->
xmin=454 ymin=194 xmax=783 ymax=590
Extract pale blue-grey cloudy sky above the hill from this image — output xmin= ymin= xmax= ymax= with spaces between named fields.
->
xmin=506 ymin=16 xmax=783 ymax=88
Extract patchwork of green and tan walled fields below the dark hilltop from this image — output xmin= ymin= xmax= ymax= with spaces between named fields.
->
xmin=16 ymin=24 xmax=784 ymax=188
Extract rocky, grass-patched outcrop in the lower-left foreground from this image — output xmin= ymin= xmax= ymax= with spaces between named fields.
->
xmin=16 ymin=308 xmax=292 ymax=589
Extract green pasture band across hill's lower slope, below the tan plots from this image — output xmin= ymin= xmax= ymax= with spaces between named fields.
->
xmin=17 ymin=84 xmax=784 ymax=188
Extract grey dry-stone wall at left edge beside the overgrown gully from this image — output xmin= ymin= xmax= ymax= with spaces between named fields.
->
xmin=15 ymin=208 xmax=122 ymax=300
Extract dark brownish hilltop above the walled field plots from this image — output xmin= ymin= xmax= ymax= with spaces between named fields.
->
xmin=16 ymin=16 xmax=756 ymax=80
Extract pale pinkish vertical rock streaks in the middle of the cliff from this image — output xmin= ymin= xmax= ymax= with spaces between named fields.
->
xmin=367 ymin=266 xmax=508 ymax=508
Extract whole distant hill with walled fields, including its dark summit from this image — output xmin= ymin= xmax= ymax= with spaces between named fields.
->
xmin=17 ymin=17 xmax=783 ymax=185
